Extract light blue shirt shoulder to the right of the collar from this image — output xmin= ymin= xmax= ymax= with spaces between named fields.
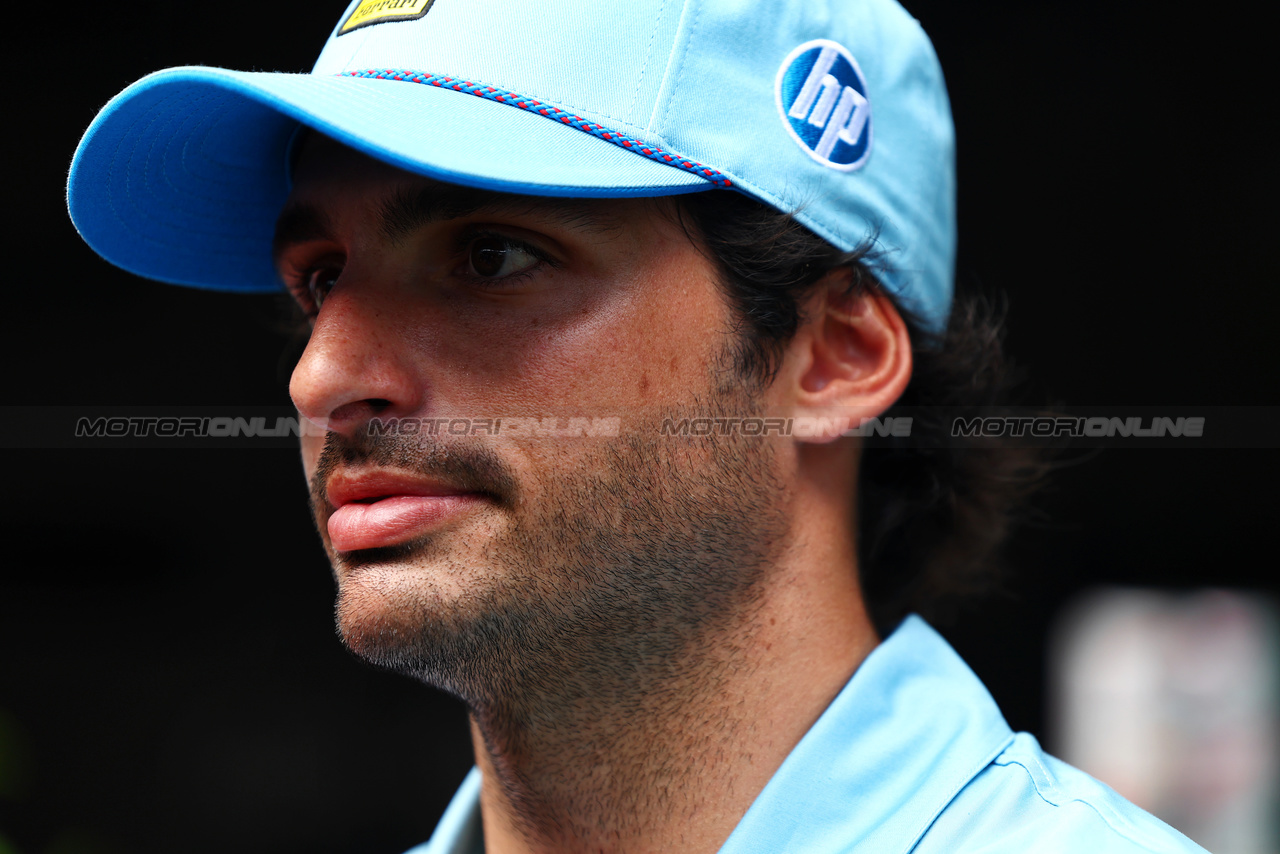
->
xmin=915 ymin=732 xmax=1204 ymax=854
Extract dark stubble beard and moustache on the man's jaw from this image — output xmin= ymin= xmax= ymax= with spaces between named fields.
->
xmin=316 ymin=387 xmax=787 ymax=731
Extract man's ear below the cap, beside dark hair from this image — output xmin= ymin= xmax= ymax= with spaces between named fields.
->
xmin=788 ymin=269 xmax=911 ymax=442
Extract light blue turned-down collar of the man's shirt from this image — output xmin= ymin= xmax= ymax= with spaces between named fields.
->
xmin=410 ymin=616 xmax=1014 ymax=854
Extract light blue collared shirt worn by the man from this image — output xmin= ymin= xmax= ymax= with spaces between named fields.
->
xmin=408 ymin=616 xmax=1203 ymax=854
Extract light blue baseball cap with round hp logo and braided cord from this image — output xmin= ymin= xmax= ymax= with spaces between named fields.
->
xmin=68 ymin=0 xmax=955 ymax=330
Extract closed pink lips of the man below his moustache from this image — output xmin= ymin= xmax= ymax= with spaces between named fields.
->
xmin=325 ymin=470 xmax=484 ymax=552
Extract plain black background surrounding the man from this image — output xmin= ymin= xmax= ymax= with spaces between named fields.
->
xmin=0 ymin=0 xmax=1280 ymax=854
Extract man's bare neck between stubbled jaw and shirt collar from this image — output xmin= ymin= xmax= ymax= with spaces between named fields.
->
xmin=471 ymin=494 xmax=878 ymax=854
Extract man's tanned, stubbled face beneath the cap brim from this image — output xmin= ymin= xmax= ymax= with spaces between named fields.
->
xmin=276 ymin=137 xmax=788 ymax=702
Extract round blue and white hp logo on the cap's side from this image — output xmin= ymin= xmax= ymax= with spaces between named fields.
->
xmin=774 ymin=38 xmax=872 ymax=172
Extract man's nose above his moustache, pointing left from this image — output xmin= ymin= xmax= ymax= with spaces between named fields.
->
xmin=289 ymin=277 xmax=426 ymax=435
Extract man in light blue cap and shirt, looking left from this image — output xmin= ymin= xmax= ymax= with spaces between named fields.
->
xmin=69 ymin=0 xmax=1197 ymax=851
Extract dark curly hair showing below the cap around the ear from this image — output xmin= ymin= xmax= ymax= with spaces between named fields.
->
xmin=677 ymin=191 xmax=1052 ymax=635
